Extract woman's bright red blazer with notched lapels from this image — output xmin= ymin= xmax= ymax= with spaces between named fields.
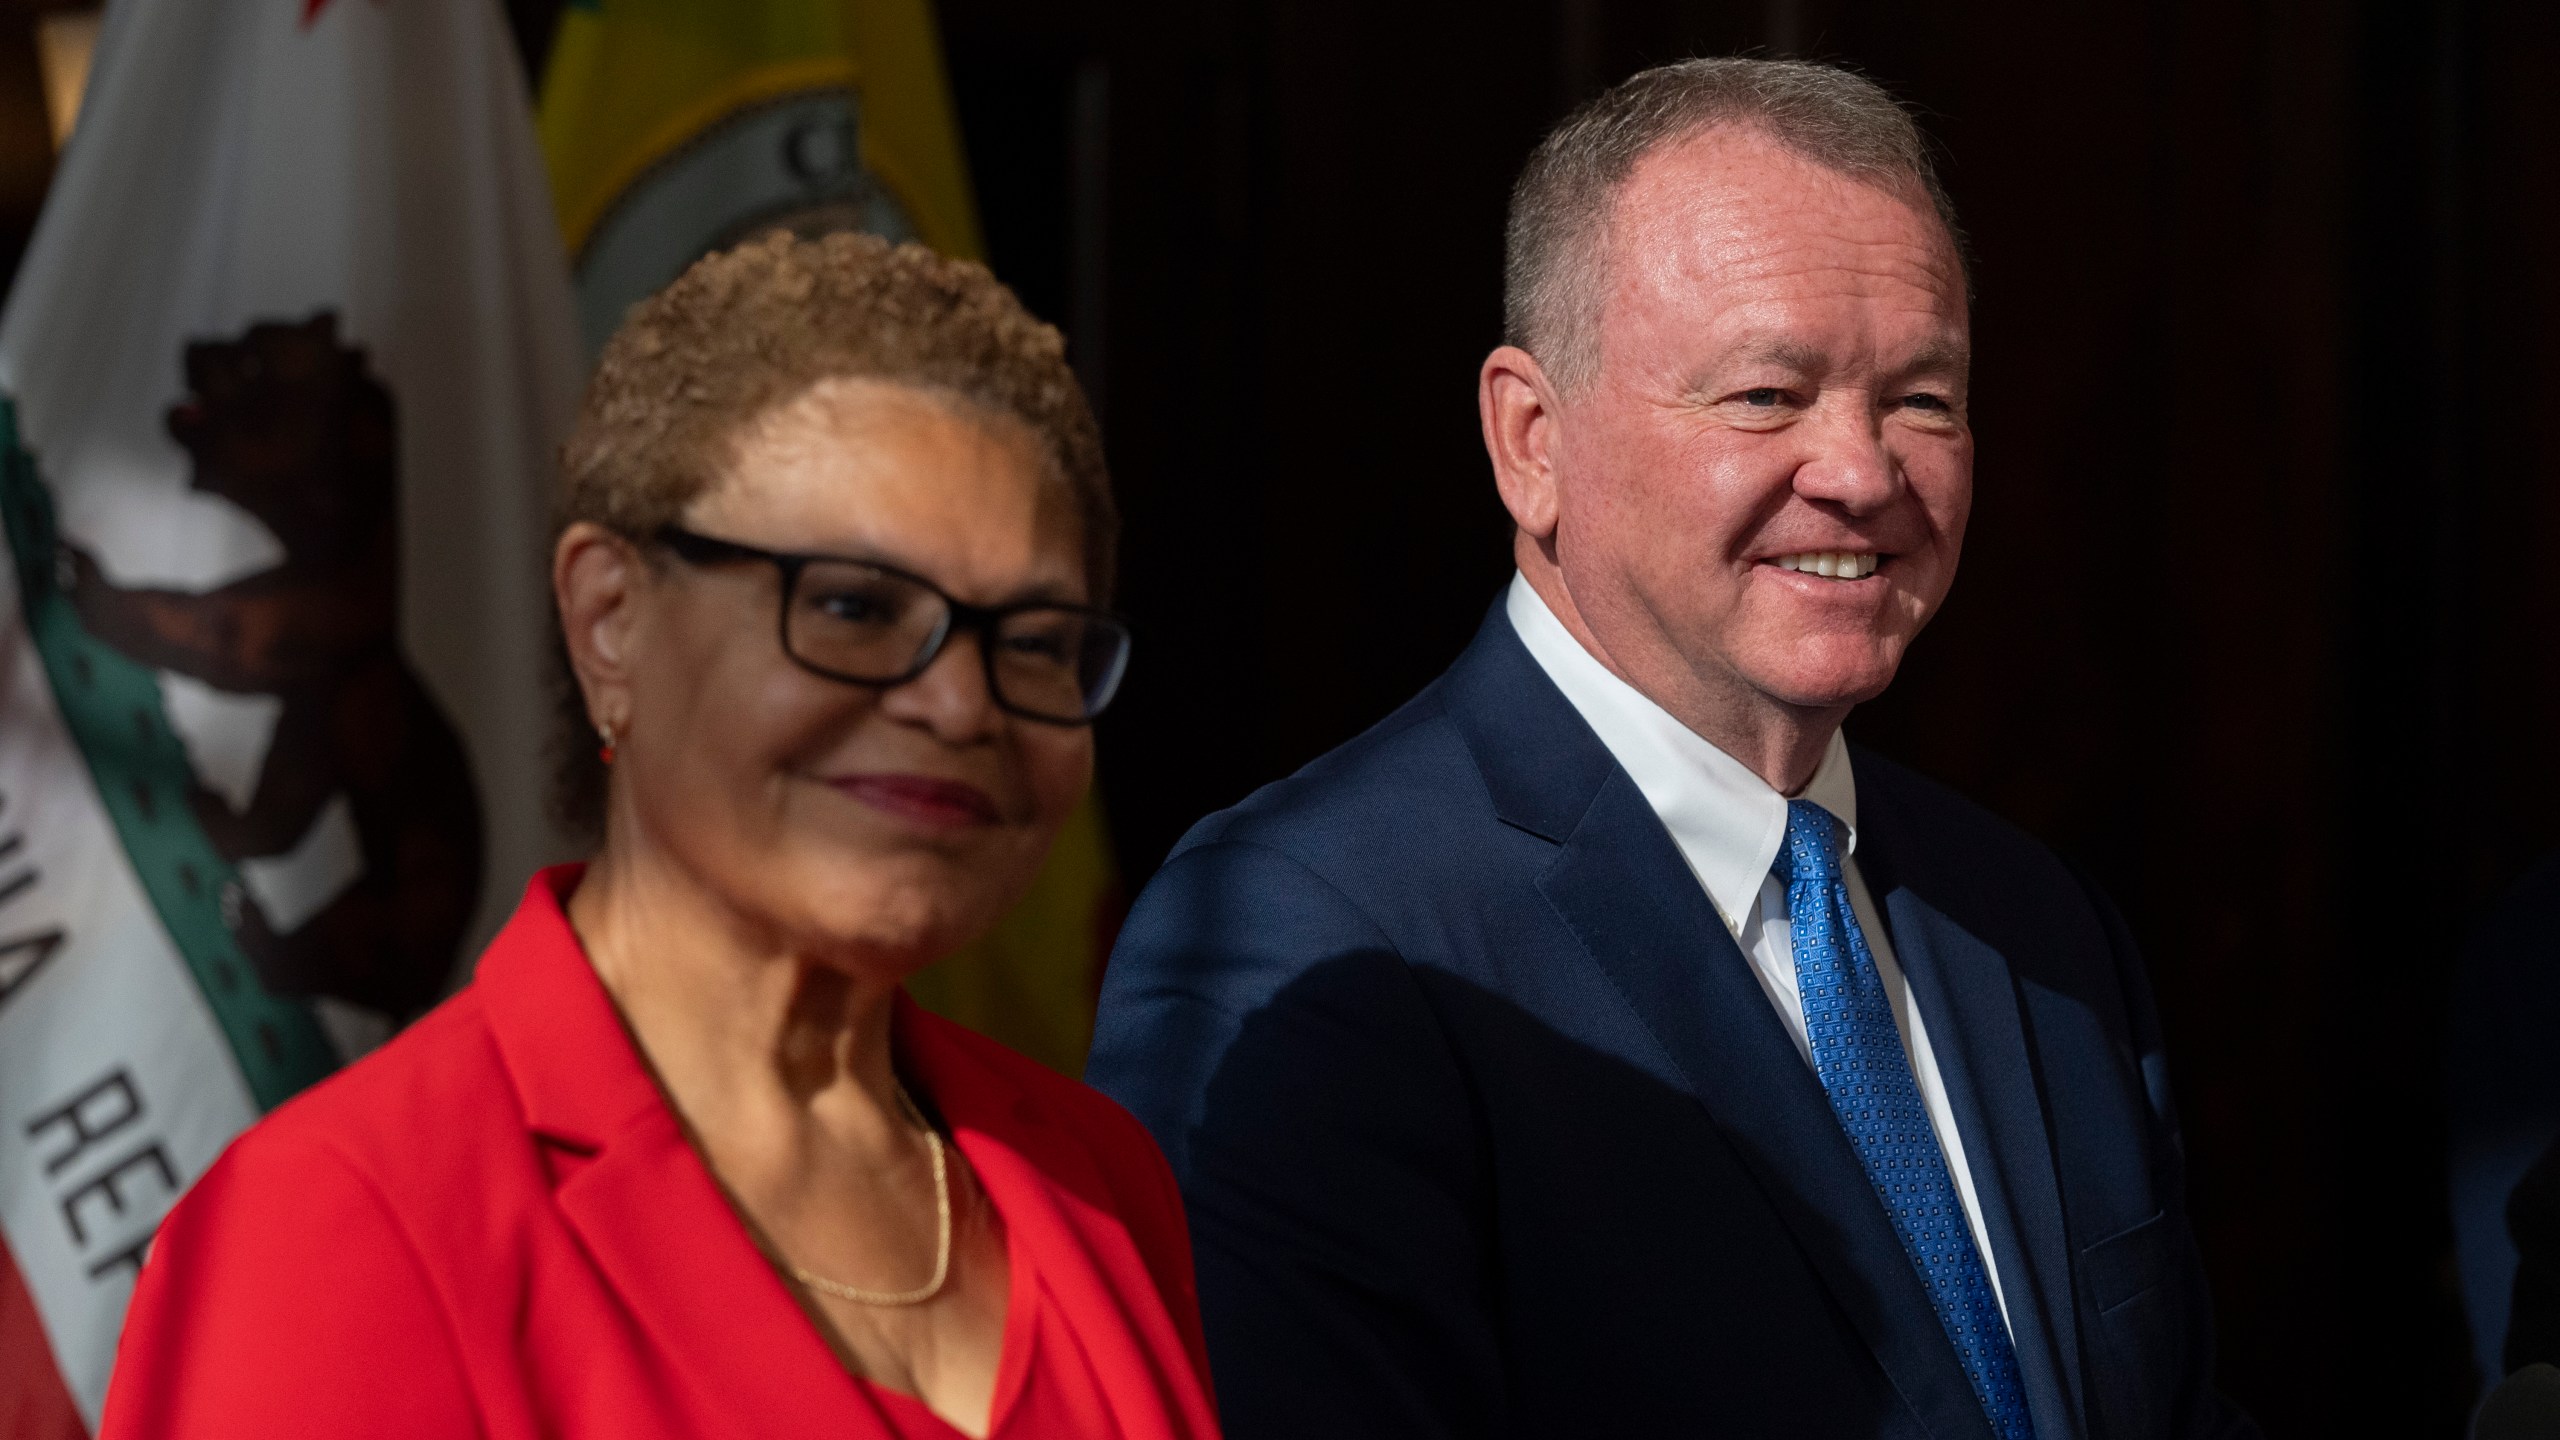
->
xmin=100 ymin=866 xmax=1216 ymax=1440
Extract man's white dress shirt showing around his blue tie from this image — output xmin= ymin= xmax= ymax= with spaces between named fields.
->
xmin=1505 ymin=574 xmax=2010 ymax=1320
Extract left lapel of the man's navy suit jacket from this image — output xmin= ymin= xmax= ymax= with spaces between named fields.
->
xmin=1539 ymin=763 xmax=1989 ymax=1440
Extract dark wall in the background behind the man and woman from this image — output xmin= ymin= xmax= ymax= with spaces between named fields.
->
xmin=0 ymin=0 xmax=2560 ymax=1435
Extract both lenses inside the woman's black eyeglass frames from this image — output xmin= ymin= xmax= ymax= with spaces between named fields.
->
xmin=783 ymin=561 xmax=1129 ymax=723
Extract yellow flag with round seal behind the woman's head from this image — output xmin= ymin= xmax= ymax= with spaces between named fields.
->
xmin=540 ymin=0 xmax=1119 ymax=1074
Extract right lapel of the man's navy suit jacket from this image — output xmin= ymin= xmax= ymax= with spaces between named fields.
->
xmin=1859 ymin=794 xmax=2089 ymax=1440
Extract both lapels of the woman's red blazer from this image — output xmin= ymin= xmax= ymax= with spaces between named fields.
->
xmin=474 ymin=866 xmax=1216 ymax=1440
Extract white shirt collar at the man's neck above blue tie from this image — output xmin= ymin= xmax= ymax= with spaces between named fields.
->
xmin=1503 ymin=574 xmax=1859 ymax=933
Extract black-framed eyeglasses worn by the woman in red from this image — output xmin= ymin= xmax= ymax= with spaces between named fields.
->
xmin=655 ymin=525 xmax=1129 ymax=725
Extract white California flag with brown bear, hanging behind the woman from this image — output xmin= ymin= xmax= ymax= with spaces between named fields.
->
xmin=0 ymin=0 xmax=581 ymax=1440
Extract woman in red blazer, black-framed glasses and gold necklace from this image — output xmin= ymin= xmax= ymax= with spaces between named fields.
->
xmin=102 ymin=236 xmax=1216 ymax=1440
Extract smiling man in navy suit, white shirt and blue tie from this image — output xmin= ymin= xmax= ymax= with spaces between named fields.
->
xmin=1091 ymin=59 xmax=2253 ymax=1440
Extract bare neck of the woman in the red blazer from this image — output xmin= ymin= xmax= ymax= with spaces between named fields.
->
xmin=568 ymin=846 xmax=901 ymax=1153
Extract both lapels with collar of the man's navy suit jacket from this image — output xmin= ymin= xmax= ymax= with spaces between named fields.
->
xmin=1444 ymin=602 xmax=2086 ymax=1440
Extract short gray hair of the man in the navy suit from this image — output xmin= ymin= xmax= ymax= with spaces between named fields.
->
xmin=1503 ymin=56 xmax=1964 ymax=389
